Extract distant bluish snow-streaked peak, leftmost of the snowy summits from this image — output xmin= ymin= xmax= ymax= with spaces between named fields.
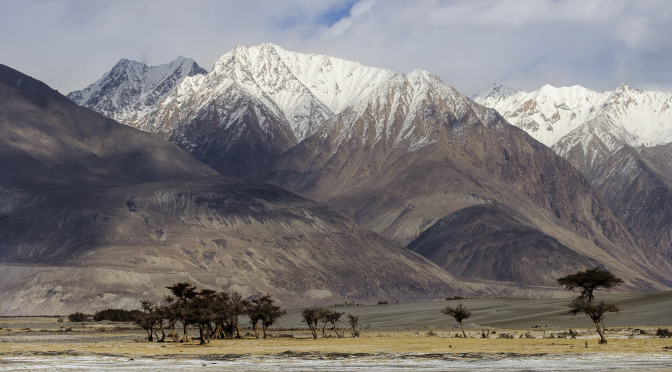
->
xmin=68 ymin=56 xmax=207 ymax=124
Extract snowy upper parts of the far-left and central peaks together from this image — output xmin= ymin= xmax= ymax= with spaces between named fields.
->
xmin=70 ymin=44 xmax=510 ymax=155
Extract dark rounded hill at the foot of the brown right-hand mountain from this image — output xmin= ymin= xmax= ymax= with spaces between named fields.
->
xmin=408 ymin=205 xmax=599 ymax=286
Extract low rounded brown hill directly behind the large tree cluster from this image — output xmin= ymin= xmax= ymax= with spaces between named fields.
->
xmin=0 ymin=177 xmax=472 ymax=315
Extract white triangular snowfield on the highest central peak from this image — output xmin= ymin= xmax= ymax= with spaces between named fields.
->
xmin=209 ymin=44 xmax=397 ymax=141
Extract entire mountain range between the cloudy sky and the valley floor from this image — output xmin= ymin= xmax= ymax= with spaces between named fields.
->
xmin=0 ymin=44 xmax=672 ymax=313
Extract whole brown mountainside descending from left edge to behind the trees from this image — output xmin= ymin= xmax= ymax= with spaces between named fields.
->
xmin=0 ymin=66 xmax=486 ymax=315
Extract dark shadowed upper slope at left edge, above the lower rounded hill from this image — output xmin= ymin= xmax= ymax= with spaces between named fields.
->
xmin=0 ymin=66 xmax=216 ymax=189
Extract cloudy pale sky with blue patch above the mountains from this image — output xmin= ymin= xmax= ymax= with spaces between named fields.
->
xmin=0 ymin=0 xmax=672 ymax=94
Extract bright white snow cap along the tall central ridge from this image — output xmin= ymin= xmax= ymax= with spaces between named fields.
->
xmin=145 ymin=44 xmax=478 ymax=142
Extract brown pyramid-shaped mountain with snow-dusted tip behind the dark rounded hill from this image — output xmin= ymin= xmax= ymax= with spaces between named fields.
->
xmin=271 ymin=71 xmax=668 ymax=288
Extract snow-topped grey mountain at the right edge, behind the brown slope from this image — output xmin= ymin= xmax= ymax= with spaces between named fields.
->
xmin=475 ymin=85 xmax=672 ymax=256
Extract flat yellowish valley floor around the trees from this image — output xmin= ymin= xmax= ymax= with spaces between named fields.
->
xmin=0 ymin=293 xmax=672 ymax=371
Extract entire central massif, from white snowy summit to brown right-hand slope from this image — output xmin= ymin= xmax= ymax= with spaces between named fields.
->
xmin=67 ymin=44 xmax=672 ymax=289
